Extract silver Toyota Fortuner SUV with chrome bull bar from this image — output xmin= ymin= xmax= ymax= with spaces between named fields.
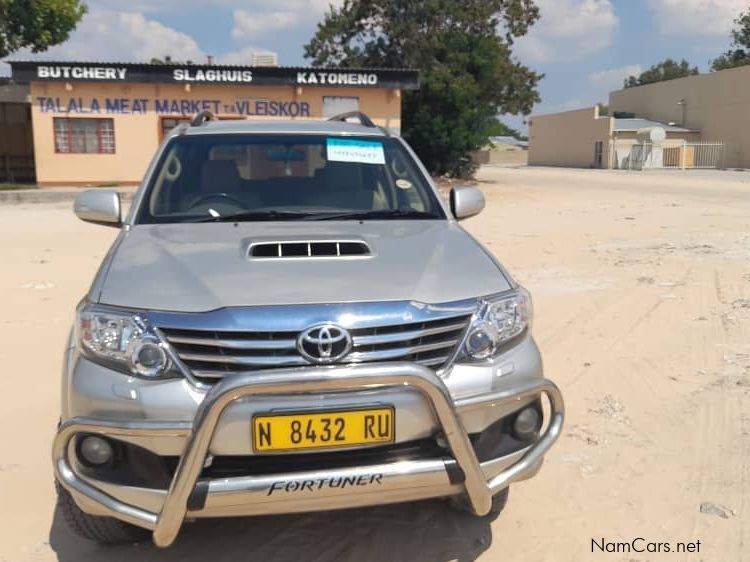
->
xmin=53 ymin=114 xmax=563 ymax=546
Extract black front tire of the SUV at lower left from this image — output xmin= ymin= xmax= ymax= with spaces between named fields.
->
xmin=55 ymin=482 xmax=149 ymax=545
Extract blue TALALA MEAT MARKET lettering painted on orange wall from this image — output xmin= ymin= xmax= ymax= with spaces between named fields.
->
xmin=36 ymin=96 xmax=310 ymax=117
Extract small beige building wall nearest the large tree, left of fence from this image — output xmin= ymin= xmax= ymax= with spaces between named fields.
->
xmin=529 ymin=107 xmax=612 ymax=168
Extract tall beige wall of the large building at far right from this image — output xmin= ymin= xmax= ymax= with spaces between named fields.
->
xmin=609 ymin=66 xmax=750 ymax=168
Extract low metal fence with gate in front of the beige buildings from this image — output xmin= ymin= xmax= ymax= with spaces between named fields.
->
xmin=620 ymin=141 xmax=724 ymax=170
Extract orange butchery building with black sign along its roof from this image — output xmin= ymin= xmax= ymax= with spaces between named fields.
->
xmin=10 ymin=61 xmax=418 ymax=186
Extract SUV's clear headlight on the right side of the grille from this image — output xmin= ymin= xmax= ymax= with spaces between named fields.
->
xmin=459 ymin=287 xmax=533 ymax=361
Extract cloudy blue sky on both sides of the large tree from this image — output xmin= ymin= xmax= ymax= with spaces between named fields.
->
xmin=0 ymin=0 xmax=750 ymax=128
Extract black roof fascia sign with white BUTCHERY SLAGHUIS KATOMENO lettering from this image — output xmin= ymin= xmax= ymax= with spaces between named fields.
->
xmin=10 ymin=61 xmax=419 ymax=90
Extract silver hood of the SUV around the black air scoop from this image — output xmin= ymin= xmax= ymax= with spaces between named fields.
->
xmin=98 ymin=220 xmax=510 ymax=312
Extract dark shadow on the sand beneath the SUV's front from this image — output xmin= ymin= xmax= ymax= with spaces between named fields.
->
xmin=50 ymin=501 xmax=492 ymax=562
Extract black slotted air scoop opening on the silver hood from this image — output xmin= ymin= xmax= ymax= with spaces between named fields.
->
xmin=247 ymin=240 xmax=372 ymax=260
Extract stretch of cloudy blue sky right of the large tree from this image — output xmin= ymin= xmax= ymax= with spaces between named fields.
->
xmin=511 ymin=0 xmax=750 ymax=124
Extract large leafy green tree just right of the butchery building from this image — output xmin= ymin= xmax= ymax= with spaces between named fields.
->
xmin=305 ymin=0 xmax=542 ymax=177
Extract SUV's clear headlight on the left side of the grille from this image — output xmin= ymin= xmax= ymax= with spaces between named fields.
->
xmin=76 ymin=305 xmax=173 ymax=378
